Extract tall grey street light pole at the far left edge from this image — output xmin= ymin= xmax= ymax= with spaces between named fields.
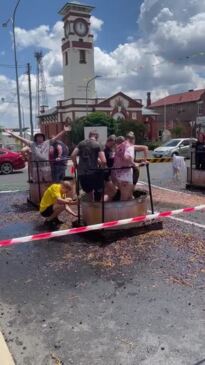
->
xmin=3 ymin=0 xmax=23 ymax=136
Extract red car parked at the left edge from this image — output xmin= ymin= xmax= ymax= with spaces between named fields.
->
xmin=0 ymin=148 xmax=25 ymax=175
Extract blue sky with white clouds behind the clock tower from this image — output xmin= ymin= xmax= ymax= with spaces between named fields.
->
xmin=0 ymin=0 xmax=205 ymax=127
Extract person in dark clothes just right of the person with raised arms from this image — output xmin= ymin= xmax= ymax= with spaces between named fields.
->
xmin=50 ymin=139 xmax=68 ymax=182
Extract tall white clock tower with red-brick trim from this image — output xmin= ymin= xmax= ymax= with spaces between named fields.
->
xmin=59 ymin=3 xmax=96 ymax=100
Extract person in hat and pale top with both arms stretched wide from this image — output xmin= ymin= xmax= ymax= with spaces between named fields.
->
xmin=6 ymin=127 xmax=69 ymax=182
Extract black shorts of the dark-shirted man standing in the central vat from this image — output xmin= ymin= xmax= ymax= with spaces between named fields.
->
xmin=79 ymin=171 xmax=104 ymax=193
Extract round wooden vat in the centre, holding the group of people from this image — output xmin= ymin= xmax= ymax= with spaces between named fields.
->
xmin=81 ymin=191 xmax=148 ymax=228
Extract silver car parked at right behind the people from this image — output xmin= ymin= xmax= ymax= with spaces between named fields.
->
xmin=153 ymin=138 xmax=197 ymax=158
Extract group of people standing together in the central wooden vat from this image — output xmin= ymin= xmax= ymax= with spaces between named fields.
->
xmin=71 ymin=131 xmax=148 ymax=201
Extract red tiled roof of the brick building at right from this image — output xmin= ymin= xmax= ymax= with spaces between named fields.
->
xmin=149 ymin=89 xmax=205 ymax=108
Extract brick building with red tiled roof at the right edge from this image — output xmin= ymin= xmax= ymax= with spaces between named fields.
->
xmin=149 ymin=89 xmax=205 ymax=137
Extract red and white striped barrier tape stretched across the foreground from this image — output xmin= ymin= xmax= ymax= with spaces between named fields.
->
xmin=0 ymin=205 xmax=205 ymax=247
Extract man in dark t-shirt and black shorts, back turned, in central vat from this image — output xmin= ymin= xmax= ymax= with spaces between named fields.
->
xmin=71 ymin=131 xmax=106 ymax=201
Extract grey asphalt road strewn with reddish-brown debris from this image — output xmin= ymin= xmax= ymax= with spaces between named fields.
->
xmin=0 ymin=164 xmax=205 ymax=365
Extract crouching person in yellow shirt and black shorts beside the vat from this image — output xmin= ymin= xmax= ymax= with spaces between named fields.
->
xmin=40 ymin=181 xmax=77 ymax=228
